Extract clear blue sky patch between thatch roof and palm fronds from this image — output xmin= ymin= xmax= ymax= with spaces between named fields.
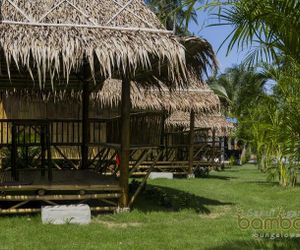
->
xmin=189 ymin=12 xmax=246 ymax=72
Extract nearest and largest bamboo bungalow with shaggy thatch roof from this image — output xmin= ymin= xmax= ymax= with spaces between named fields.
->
xmin=0 ymin=0 xmax=195 ymax=214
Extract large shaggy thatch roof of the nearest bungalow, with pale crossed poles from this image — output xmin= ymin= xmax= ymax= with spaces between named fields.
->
xmin=0 ymin=0 xmax=202 ymax=89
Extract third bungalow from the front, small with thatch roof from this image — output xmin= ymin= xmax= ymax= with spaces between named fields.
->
xmin=166 ymin=111 xmax=234 ymax=173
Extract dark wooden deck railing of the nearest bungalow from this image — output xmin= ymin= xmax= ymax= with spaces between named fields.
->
xmin=0 ymin=119 xmax=108 ymax=147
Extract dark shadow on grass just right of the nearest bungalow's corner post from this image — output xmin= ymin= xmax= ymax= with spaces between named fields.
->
xmin=130 ymin=182 xmax=234 ymax=214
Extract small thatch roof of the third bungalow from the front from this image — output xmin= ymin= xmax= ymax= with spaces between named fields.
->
xmin=166 ymin=111 xmax=235 ymax=136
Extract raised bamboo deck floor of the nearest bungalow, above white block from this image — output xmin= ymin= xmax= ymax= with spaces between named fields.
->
xmin=0 ymin=170 xmax=121 ymax=214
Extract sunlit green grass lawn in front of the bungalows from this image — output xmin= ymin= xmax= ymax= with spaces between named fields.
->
xmin=0 ymin=165 xmax=300 ymax=250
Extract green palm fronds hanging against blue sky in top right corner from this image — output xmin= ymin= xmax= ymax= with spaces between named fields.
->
xmin=185 ymin=0 xmax=300 ymax=64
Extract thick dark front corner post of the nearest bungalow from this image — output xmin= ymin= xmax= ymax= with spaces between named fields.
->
xmin=120 ymin=79 xmax=131 ymax=209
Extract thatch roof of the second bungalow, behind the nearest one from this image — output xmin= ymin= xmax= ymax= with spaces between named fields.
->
xmin=92 ymin=76 xmax=220 ymax=113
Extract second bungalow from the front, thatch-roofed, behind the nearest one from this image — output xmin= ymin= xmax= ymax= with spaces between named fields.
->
xmin=91 ymin=75 xmax=220 ymax=176
